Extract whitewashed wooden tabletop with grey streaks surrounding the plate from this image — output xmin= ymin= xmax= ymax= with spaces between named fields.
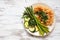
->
xmin=0 ymin=0 xmax=60 ymax=40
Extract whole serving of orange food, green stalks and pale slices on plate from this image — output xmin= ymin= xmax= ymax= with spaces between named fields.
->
xmin=23 ymin=4 xmax=54 ymax=36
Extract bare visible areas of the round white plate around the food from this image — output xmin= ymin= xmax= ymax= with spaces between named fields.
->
xmin=25 ymin=3 xmax=55 ymax=36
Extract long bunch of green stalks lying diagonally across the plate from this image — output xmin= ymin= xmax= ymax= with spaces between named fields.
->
xmin=22 ymin=6 xmax=49 ymax=36
